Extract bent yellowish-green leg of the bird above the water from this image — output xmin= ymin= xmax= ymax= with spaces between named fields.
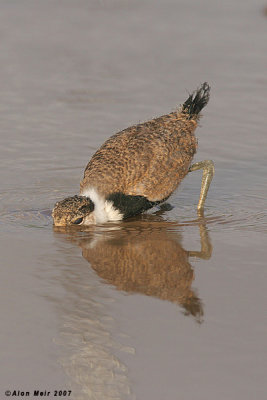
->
xmin=189 ymin=160 xmax=214 ymax=210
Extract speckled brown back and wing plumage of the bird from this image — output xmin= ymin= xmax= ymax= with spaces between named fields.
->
xmin=81 ymin=111 xmax=198 ymax=201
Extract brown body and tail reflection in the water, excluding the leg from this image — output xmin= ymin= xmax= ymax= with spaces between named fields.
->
xmin=69 ymin=224 xmax=203 ymax=320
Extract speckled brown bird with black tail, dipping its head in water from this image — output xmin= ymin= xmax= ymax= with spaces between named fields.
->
xmin=52 ymin=82 xmax=214 ymax=226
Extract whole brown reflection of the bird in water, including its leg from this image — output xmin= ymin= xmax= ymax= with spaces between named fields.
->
xmin=54 ymin=215 xmax=212 ymax=322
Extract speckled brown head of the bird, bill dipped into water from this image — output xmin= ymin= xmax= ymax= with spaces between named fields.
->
xmin=52 ymin=196 xmax=95 ymax=226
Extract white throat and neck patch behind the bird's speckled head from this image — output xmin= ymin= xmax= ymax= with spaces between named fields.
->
xmin=80 ymin=188 xmax=123 ymax=224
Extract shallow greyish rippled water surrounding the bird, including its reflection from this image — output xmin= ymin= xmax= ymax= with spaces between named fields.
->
xmin=0 ymin=0 xmax=267 ymax=400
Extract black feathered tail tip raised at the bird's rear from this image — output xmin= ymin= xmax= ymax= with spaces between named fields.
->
xmin=182 ymin=82 xmax=210 ymax=119
